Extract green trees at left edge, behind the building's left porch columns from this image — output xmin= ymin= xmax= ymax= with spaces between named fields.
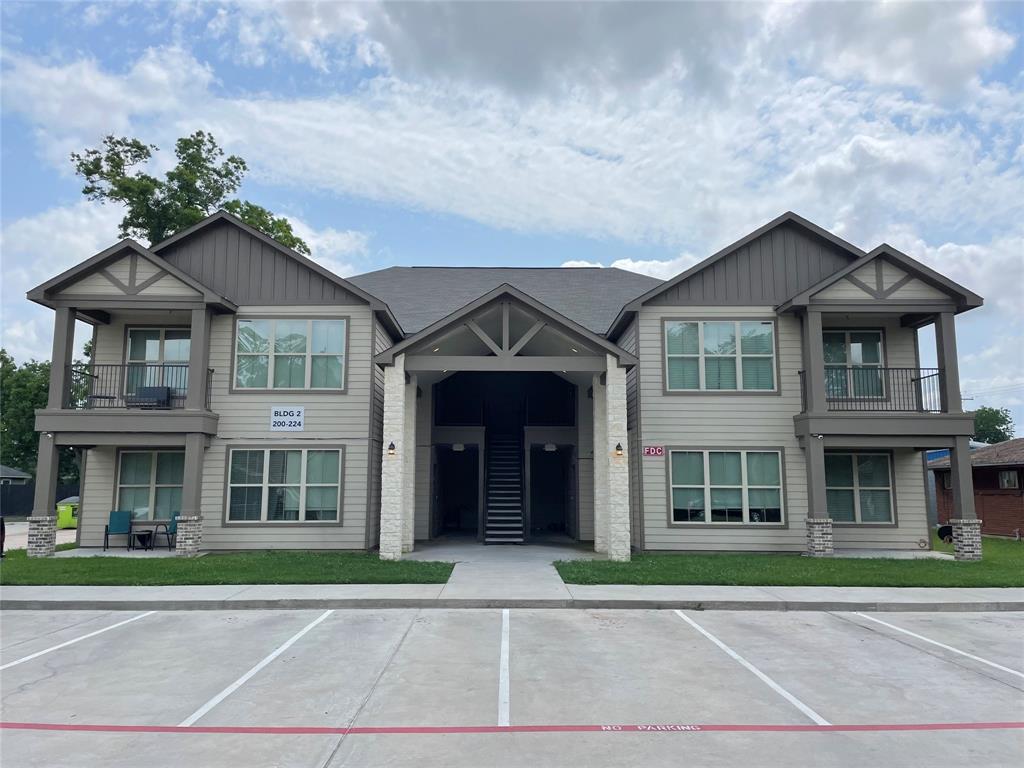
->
xmin=0 ymin=349 xmax=79 ymax=483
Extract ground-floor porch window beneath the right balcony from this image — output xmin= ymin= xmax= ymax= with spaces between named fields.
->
xmin=825 ymin=453 xmax=893 ymax=523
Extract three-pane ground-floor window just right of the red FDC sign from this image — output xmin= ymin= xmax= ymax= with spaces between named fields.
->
xmin=669 ymin=451 xmax=784 ymax=524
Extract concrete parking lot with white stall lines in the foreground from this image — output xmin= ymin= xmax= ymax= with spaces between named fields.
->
xmin=0 ymin=609 xmax=1024 ymax=768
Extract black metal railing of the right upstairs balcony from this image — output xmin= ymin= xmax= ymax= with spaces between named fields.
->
xmin=800 ymin=366 xmax=943 ymax=414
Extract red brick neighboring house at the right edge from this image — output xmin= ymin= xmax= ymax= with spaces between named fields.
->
xmin=928 ymin=437 xmax=1024 ymax=538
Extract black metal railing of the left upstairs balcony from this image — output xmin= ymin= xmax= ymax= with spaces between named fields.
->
xmin=65 ymin=362 xmax=213 ymax=411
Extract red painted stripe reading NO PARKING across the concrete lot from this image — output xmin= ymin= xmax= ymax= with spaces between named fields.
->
xmin=0 ymin=722 xmax=1024 ymax=735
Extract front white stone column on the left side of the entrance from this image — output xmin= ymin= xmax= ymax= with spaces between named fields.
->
xmin=380 ymin=354 xmax=406 ymax=560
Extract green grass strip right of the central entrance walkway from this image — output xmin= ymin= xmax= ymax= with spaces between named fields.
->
xmin=555 ymin=537 xmax=1024 ymax=587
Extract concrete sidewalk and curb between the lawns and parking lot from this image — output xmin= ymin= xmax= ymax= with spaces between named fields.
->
xmin=0 ymin=574 xmax=1024 ymax=611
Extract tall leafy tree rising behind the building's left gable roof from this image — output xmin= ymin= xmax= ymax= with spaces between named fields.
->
xmin=71 ymin=131 xmax=309 ymax=255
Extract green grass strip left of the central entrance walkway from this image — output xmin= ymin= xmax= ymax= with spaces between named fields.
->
xmin=0 ymin=545 xmax=454 ymax=587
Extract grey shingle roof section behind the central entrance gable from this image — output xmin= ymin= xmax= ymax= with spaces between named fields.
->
xmin=348 ymin=266 xmax=662 ymax=334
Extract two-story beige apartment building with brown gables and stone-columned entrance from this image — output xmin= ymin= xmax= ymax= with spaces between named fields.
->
xmin=29 ymin=212 xmax=982 ymax=559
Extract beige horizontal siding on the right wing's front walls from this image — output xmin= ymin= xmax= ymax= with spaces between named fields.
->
xmin=638 ymin=306 xmax=928 ymax=552
